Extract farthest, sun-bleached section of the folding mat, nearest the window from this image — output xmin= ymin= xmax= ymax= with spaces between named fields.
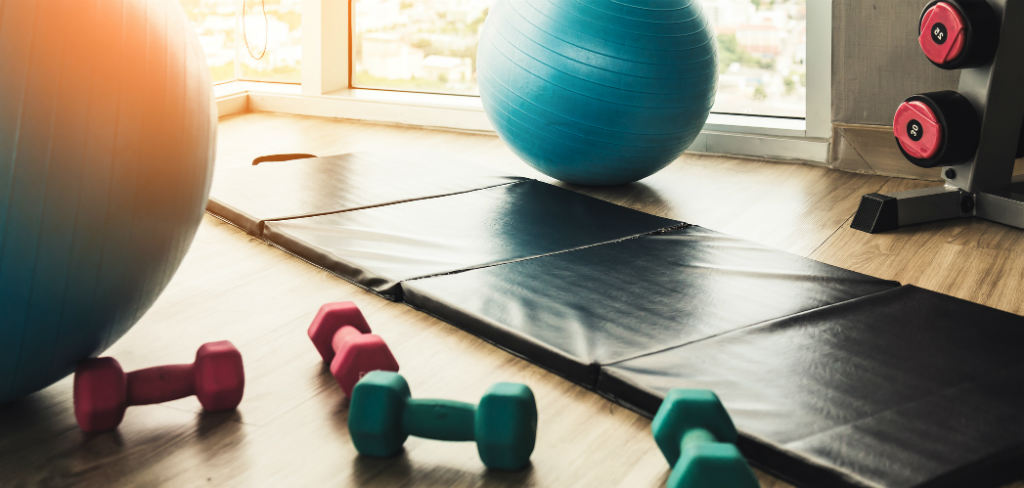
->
xmin=207 ymin=153 xmax=522 ymax=235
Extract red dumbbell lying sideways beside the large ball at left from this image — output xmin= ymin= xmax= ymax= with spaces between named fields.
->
xmin=75 ymin=341 xmax=246 ymax=432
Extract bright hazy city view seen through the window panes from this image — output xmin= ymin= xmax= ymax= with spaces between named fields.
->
xmin=180 ymin=0 xmax=807 ymax=118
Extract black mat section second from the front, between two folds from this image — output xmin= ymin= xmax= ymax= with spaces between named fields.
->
xmin=402 ymin=226 xmax=897 ymax=387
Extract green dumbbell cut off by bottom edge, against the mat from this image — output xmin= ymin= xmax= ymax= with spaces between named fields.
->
xmin=651 ymin=390 xmax=758 ymax=488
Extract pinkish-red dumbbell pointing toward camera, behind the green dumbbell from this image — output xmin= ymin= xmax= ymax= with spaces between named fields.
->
xmin=308 ymin=302 xmax=398 ymax=397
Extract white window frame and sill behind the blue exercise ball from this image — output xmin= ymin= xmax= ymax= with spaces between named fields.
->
xmin=219 ymin=0 xmax=833 ymax=163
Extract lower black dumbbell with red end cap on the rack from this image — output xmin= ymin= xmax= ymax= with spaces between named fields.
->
xmin=893 ymin=91 xmax=981 ymax=168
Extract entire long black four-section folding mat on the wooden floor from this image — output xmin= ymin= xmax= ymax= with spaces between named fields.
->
xmin=205 ymin=160 xmax=1024 ymax=486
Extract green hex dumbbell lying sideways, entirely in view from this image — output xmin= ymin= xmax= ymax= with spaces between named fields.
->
xmin=348 ymin=371 xmax=537 ymax=470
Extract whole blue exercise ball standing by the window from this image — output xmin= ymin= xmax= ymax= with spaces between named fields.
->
xmin=477 ymin=0 xmax=718 ymax=185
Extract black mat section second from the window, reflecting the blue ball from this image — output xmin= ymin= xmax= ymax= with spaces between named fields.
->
xmin=263 ymin=180 xmax=683 ymax=299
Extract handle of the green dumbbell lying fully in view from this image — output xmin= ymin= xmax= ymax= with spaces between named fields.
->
xmin=401 ymin=399 xmax=476 ymax=441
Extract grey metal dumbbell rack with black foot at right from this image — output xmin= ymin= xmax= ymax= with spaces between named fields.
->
xmin=851 ymin=0 xmax=1024 ymax=233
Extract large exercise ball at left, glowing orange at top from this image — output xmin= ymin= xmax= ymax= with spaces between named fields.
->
xmin=0 ymin=0 xmax=216 ymax=403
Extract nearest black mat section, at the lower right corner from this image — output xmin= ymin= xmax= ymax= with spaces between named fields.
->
xmin=598 ymin=286 xmax=1024 ymax=486
